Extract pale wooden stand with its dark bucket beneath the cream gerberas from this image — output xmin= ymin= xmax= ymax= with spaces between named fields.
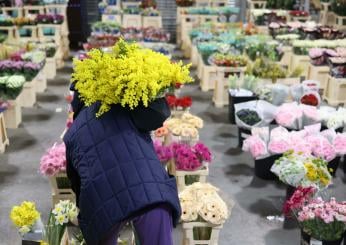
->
xmin=182 ymin=222 xmax=223 ymax=245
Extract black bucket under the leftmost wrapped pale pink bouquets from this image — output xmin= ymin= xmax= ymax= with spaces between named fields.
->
xmin=255 ymin=155 xmax=282 ymax=180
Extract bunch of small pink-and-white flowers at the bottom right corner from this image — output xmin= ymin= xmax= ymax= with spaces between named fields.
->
xmin=298 ymin=197 xmax=346 ymax=224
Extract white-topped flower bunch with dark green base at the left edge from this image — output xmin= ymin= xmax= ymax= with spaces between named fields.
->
xmin=0 ymin=75 xmax=25 ymax=100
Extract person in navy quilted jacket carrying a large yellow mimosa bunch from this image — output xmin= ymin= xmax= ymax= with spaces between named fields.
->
xmin=64 ymin=40 xmax=192 ymax=245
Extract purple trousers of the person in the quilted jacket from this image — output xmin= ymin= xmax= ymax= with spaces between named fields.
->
xmin=99 ymin=205 xmax=173 ymax=245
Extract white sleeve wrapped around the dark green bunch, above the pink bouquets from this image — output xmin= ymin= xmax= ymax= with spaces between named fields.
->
xmin=234 ymin=100 xmax=276 ymax=130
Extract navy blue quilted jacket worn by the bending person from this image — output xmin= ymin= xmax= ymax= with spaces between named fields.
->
xmin=64 ymin=104 xmax=181 ymax=245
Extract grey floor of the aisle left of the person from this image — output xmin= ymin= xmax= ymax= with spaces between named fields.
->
xmin=0 ymin=63 xmax=72 ymax=245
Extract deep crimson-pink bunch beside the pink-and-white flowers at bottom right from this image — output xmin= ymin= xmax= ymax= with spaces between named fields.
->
xmin=283 ymin=186 xmax=316 ymax=216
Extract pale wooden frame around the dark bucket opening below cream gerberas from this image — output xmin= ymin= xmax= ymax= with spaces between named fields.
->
xmin=182 ymin=222 xmax=223 ymax=245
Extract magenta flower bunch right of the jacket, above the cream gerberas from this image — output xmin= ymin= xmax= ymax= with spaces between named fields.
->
xmin=171 ymin=143 xmax=211 ymax=171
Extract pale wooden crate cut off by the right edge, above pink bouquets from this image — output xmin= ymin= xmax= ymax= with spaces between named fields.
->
xmin=323 ymin=75 xmax=346 ymax=106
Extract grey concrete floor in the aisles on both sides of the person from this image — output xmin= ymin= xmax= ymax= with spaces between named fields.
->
xmin=0 ymin=59 xmax=346 ymax=245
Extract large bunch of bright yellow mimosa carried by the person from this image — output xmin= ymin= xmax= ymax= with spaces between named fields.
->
xmin=72 ymin=40 xmax=192 ymax=116
